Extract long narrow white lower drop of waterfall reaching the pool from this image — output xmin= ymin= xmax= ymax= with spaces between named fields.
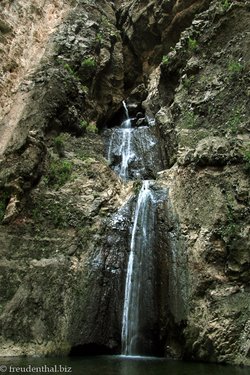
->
xmin=122 ymin=181 xmax=154 ymax=355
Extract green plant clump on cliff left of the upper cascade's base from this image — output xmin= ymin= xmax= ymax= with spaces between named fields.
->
xmin=47 ymin=159 xmax=73 ymax=189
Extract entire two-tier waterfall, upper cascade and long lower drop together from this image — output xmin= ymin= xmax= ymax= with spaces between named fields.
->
xmin=104 ymin=101 xmax=165 ymax=355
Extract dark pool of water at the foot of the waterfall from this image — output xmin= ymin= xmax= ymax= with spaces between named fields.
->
xmin=0 ymin=356 xmax=250 ymax=375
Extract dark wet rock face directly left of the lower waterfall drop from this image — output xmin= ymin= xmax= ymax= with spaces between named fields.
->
xmin=66 ymin=201 xmax=131 ymax=355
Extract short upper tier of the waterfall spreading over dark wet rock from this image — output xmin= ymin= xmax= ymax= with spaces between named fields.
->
xmin=104 ymin=101 xmax=162 ymax=181
